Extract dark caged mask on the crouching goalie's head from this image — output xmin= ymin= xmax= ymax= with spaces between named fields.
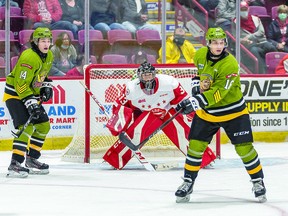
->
xmin=137 ymin=62 xmax=156 ymax=90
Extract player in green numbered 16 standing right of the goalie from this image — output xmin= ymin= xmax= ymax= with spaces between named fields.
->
xmin=175 ymin=28 xmax=266 ymax=202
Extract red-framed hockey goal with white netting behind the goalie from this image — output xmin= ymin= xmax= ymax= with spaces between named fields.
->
xmin=62 ymin=64 xmax=220 ymax=163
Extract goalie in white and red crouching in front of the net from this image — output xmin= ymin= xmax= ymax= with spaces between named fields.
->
xmin=103 ymin=62 xmax=216 ymax=169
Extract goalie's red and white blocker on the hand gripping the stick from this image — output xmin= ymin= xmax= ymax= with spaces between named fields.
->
xmin=106 ymin=105 xmax=133 ymax=136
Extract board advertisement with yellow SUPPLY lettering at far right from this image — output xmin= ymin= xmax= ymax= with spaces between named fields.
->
xmin=241 ymin=77 xmax=288 ymax=131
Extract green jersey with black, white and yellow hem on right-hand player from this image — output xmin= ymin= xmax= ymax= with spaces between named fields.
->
xmin=194 ymin=47 xmax=248 ymax=122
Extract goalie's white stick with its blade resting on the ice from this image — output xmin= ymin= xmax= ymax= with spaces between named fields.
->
xmin=79 ymin=81 xmax=178 ymax=171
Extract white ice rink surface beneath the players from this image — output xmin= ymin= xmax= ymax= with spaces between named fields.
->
xmin=0 ymin=143 xmax=288 ymax=216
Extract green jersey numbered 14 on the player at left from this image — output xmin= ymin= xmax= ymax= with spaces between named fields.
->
xmin=3 ymin=48 xmax=53 ymax=101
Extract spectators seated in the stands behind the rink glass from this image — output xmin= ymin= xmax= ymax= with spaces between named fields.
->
xmin=0 ymin=0 xmax=288 ymax=76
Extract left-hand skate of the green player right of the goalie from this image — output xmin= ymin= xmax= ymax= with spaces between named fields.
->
xmin=175 ymin=178 xmax=194 ymax=203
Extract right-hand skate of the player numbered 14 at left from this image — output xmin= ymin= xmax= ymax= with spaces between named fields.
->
xmin=25 ymin=156 xmax=49 ymax=175
